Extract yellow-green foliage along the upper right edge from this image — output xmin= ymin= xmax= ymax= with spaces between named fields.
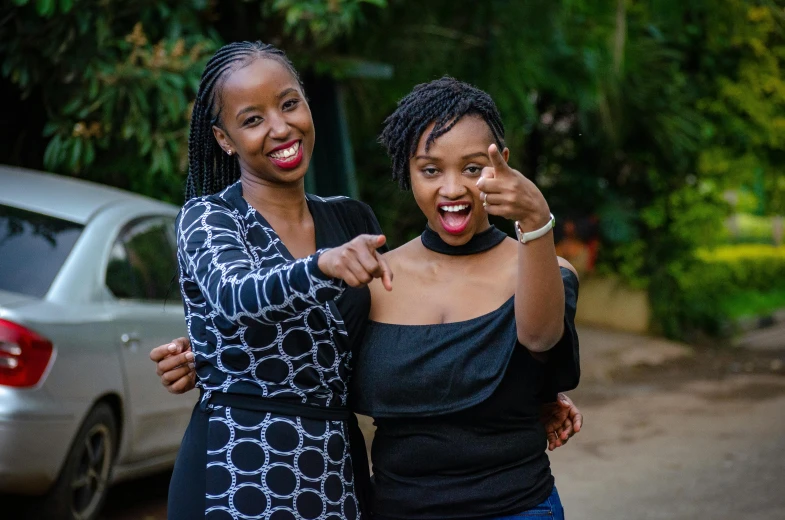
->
xmin=698 ymin=0 xmax=785 ymax=215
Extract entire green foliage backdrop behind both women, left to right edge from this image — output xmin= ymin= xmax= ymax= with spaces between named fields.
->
xmin=0 ymin=0 xmax=785 ymax=337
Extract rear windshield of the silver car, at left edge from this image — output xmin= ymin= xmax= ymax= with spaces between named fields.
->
xmin=0 ymin=204 xmax=84 ymax=298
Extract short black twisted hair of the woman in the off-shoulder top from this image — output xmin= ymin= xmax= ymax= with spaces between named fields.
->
xmin=379 ymin=76 xmax=504 ymax=190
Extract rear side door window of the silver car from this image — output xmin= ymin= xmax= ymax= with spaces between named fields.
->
xmin=106 ymin=217 xmax=180 ymax=301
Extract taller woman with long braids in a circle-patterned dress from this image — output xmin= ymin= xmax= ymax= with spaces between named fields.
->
xmin=169 ymin=42 xmax=392 ymax=520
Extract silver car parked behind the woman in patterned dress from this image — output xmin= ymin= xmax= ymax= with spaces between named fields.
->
xmin=0 ymin=166 xmax=195 ymax=519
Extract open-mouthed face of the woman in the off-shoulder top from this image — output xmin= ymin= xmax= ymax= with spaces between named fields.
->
xmin=409 ymin=116 xmax=509 ymax=246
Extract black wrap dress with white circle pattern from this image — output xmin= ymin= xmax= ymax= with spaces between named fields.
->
xmin=168 ymin=182 xmax=379 ymax=520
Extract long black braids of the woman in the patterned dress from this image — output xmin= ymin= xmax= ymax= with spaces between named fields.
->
xmin=185 ymin=41 xmax=302 ymax=200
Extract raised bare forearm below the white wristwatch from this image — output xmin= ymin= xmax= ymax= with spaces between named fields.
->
xmin=515 ymin=232 xmax=564 ymax=352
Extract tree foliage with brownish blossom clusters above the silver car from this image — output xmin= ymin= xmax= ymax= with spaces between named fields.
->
xmin=0 ymin=0 xmax=385 ymax=202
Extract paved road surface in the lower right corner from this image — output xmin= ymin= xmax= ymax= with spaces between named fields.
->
xmin=552 ymin=374 xmax=785 ymax=520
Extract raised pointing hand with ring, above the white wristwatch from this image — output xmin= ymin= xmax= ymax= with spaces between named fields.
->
xmin=477 ymin=144 xmax=550 ymax=231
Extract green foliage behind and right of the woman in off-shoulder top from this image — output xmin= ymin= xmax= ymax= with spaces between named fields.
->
xmin=348 ymin=0 xmax=785 ymax=337
